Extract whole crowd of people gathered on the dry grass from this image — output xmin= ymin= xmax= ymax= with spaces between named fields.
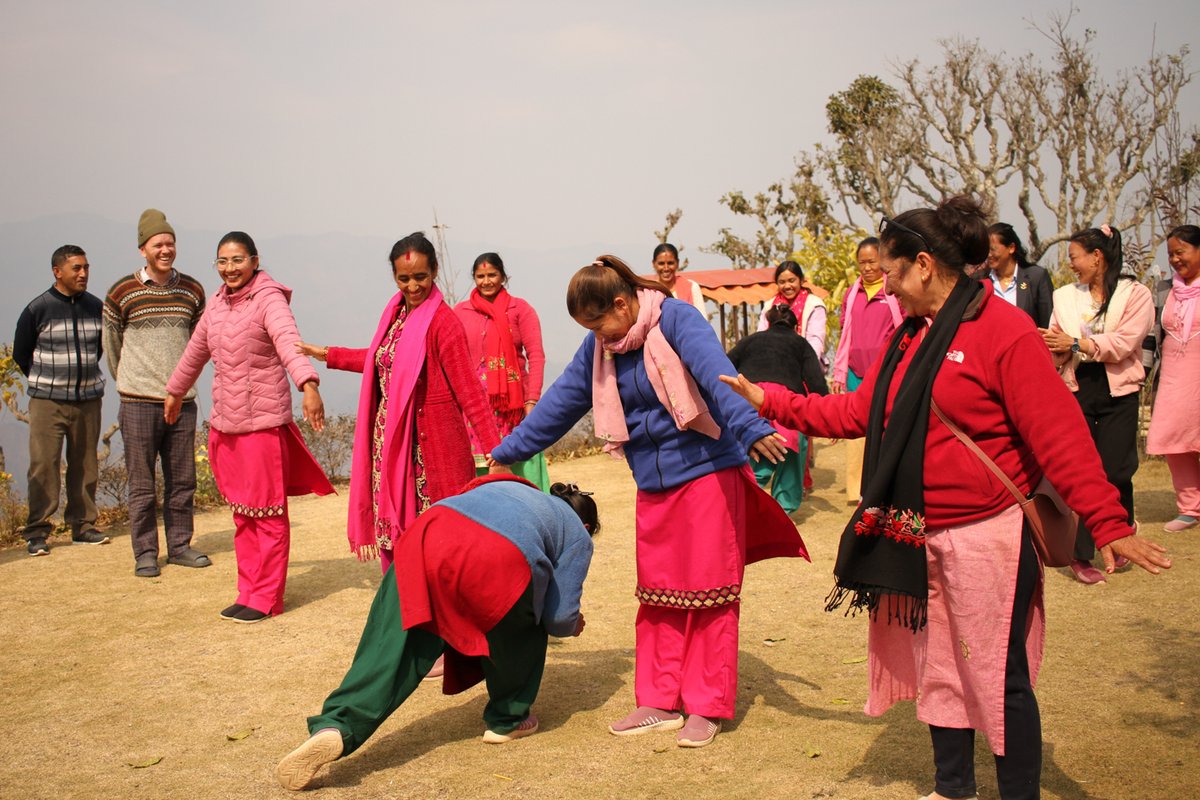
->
xmin=13 ymin=203 xmax=1185 ymax=799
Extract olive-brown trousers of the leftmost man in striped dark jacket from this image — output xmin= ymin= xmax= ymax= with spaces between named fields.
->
xmin=22 ymin=397 xmax=101 ymax=541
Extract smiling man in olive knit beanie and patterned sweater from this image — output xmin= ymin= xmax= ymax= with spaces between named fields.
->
xmin=104 ymin=209 xmax=212 ymax=578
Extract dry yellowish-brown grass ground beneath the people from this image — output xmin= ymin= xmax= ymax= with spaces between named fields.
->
xmin=0 ymin=445 xmax=1200 ymax=800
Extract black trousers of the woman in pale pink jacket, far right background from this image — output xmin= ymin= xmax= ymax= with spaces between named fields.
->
xmin=1075 ymin=362 xmax=1139 ymax=561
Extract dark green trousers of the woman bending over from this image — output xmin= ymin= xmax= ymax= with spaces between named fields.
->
xmin=308 ymin=565 xmax=546 ymax=757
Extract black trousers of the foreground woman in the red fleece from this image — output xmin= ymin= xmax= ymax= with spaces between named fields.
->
xmin=929 ymin=529 xmax=1042 ymax=800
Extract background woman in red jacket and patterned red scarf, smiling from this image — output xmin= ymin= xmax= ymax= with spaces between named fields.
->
xmin=454 ymin=253 xmax=550 ymax=492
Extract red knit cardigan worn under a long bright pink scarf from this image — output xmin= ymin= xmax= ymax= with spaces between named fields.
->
xmin=325 ymin=305 xmax=500 ymax=503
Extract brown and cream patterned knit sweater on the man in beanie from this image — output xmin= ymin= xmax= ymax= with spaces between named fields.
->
xmin=104 ymin=270 xmax=204 ymax=403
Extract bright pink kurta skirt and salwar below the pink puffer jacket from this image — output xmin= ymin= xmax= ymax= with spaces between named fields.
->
xmin=209 ymin=422 xmax=334 ymax=614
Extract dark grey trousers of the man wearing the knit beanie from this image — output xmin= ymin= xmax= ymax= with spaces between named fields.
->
xmin=118 ymin=399 xmax=196 ymax=559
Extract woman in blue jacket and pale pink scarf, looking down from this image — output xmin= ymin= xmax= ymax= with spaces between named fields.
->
xmin=491 ymin=255 xmax=806 ymax=747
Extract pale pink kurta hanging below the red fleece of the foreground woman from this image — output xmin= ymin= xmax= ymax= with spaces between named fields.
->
xmin=863 ymin=505 xmax=1045 ymax=756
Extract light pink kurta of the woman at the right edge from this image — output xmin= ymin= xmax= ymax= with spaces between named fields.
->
xmin=1146 ymin=290 xmax=1200 ymax=456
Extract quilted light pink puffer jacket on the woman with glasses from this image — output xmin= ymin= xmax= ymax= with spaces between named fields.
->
xmin=167 ymin=270 xmax=318 ymax=433
